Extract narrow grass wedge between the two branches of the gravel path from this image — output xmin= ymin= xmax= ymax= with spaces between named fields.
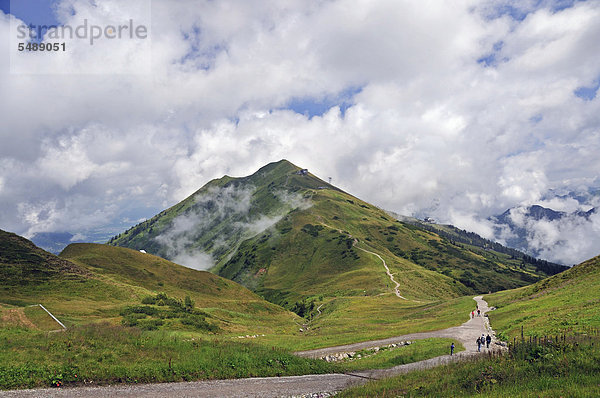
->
xmin=341 ymin=338 xmax=465 ymax=371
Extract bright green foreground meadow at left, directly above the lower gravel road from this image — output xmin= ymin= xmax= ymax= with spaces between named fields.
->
xmin=0 ymin=323 xmax=339 ymax=389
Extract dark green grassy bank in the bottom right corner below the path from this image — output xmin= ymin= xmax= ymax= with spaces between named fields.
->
xmin=336 ymin=337 xmax=600 ymax=398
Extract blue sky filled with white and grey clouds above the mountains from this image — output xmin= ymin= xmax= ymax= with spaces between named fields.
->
xmin=0 ymin=0 xmax=600 ymax=263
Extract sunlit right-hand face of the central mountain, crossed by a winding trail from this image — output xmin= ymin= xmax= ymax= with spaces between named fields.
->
xmin=218 ymin=183 xmax=552 ymax=305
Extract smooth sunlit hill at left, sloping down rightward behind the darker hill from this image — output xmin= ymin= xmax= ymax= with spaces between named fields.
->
xmin=61 ymin=243 xmax=296 ymax=332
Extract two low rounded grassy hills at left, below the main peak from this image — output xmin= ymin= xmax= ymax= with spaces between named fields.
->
xmin=0 ymin=231 xmax=297 ymax=333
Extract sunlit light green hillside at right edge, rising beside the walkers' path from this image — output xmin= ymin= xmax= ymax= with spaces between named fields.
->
xmin=485 ymin=257 xmax=600 ymax=338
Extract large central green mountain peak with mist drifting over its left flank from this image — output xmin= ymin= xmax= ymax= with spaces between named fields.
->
xmin=109 ymin=160 xmax=564 ymax=313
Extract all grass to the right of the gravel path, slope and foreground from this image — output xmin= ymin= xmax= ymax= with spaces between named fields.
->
xmin=339 ymin=257 xmax=600 ymax=398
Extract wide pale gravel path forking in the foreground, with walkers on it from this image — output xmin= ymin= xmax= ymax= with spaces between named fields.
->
xmin=0 ymin=296 xmax=502 ymax=398
